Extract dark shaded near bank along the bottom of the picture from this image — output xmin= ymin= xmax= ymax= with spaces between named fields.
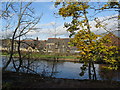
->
xmin=2 ymin=71 xmax=120 ymax=90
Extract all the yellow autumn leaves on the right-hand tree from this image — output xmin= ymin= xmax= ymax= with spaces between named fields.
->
xmin=58 ymin=2 xmax=118 ymax=70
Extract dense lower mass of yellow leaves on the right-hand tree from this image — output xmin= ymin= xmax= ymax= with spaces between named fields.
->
xmin=71 ymin=29 xmax=118 ymax=69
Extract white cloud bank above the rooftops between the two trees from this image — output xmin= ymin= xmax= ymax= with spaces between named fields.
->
xmin=26 ymin=22 xmax=69 ymax=39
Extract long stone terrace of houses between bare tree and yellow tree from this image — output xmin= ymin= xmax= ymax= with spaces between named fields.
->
xmin=18 ymin=38 xmax=78 ymax=53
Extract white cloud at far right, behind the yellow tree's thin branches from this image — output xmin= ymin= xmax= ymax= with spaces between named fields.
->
xmin=90 ymin=15 xmax=118 ymax=34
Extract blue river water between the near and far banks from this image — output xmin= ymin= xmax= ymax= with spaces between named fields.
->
xmin=1 ymin=56 xmax=120 ymax=81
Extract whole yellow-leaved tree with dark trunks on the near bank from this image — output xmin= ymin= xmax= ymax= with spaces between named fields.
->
xmin=55 ymin=2 xmax=118 ymax=80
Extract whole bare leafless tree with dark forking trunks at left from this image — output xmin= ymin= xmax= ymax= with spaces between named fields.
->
xmin=2 ymin=2 xmax=41 ymax=71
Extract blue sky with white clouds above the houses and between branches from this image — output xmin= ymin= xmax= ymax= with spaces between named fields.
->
xmin=0 ymin=2 xmax=118 ymax=40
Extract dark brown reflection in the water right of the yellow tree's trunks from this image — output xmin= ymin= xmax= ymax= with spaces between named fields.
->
xmin=99 ymin=64 xmax=120 ymax=80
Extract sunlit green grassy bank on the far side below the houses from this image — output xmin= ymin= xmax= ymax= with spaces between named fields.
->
xmin=1 ymin=52 xmax=105 ymax=64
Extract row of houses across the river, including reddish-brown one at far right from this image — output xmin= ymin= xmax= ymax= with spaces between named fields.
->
xmin=0 ymin=33 xmax=120 ymax=53
